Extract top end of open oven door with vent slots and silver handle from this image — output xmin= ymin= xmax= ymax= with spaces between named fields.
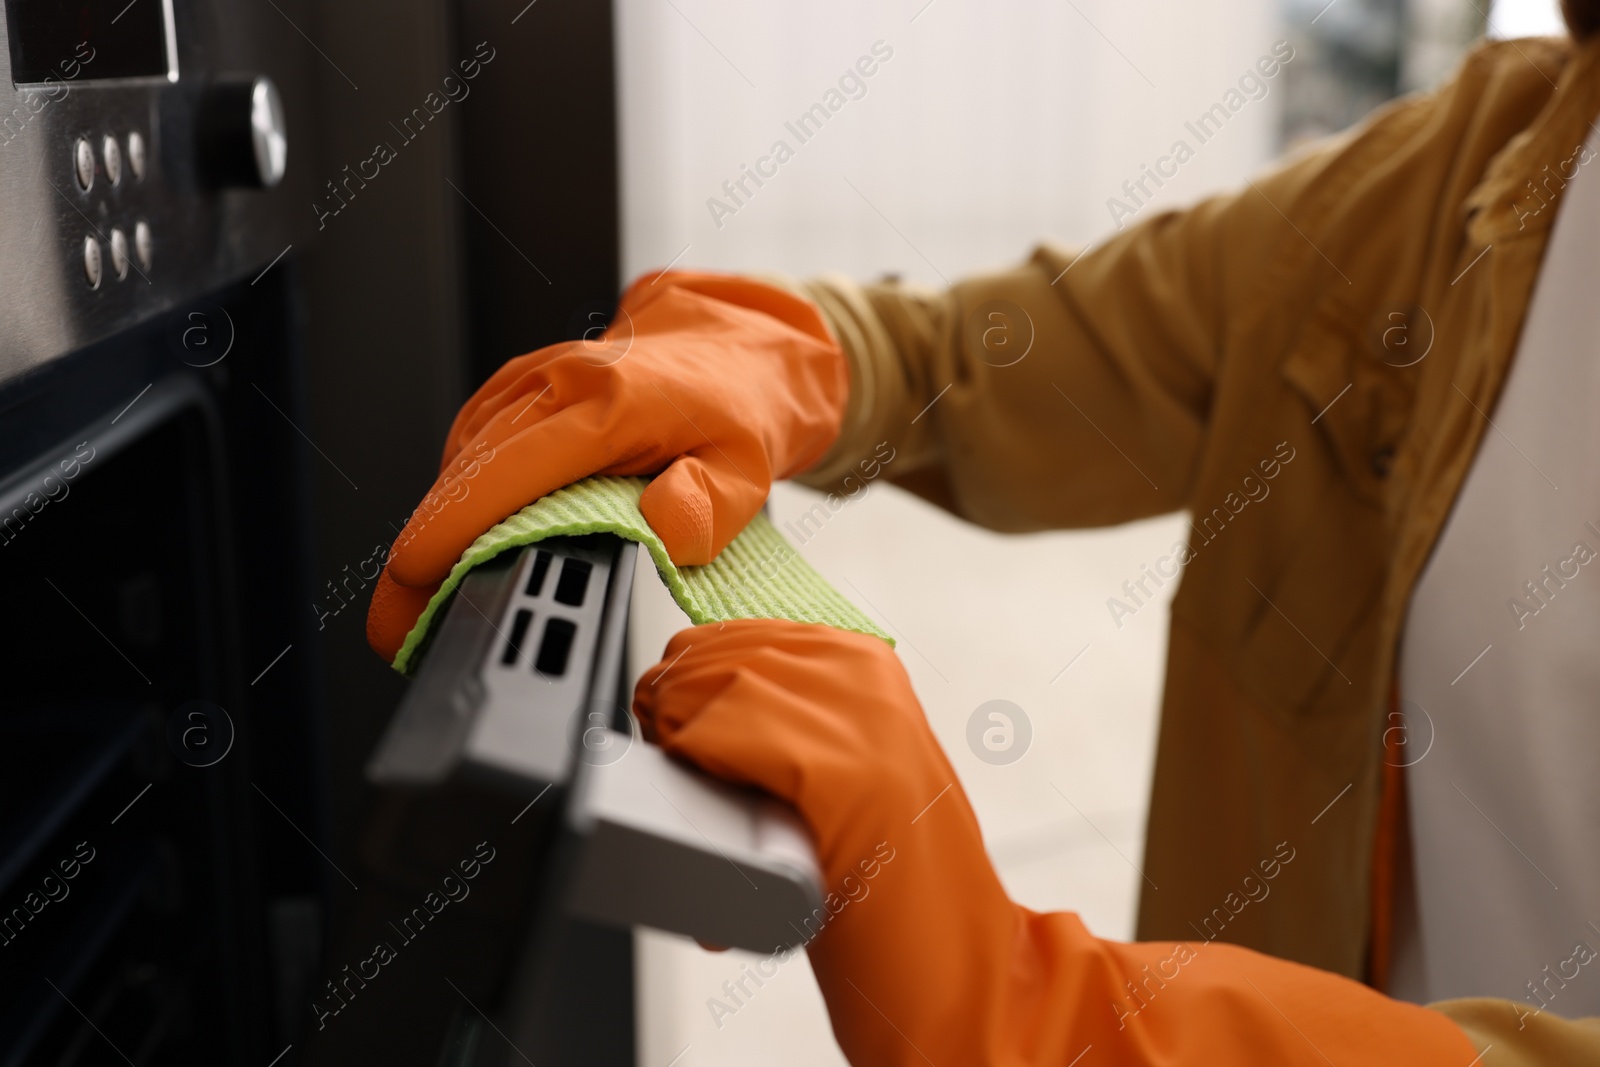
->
xmin=368 ymin=536 xmax=827 ymax=952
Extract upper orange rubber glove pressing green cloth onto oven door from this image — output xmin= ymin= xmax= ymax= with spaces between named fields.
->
xmin=366 ymin=272 xmax=850 ymax=661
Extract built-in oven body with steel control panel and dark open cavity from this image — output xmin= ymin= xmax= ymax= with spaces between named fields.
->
xmin=0 ymin=0 xmax=324 ymax=1067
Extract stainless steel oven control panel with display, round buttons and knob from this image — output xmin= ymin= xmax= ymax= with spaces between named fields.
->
xmin=0 ymin=0 xmax=315 ymax=382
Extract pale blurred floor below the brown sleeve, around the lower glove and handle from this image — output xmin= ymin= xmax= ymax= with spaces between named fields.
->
xmin=630 ymin=485 xmax=1186 ymax=1067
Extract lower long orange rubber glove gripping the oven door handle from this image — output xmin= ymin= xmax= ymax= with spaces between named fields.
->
xmin=634 ymin=619 xmax=1477 ymax=1067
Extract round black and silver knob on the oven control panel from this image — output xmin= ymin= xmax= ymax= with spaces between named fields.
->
xmin=195 ymin=75 xmax=288 ymax=189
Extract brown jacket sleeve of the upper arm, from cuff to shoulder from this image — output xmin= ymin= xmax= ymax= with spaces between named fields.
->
xmin=790 ymin=54 xmax=1459 ymax=531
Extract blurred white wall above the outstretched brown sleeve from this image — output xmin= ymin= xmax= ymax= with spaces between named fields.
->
xmin=619 ymin=0 xmax=1275 ymax=282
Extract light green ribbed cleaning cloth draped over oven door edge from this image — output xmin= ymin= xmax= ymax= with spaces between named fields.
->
xmin=394 ymin=477 xmax=894 ymax=673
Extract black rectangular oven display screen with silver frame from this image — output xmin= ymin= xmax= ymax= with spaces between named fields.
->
xmin=5 ymin=0 xmax=176 ymax=85
